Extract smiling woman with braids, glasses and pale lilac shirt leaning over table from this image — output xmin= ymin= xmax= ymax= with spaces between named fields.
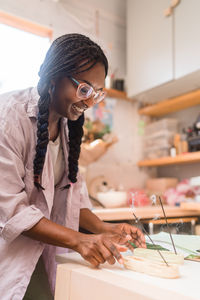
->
xmin=0 ymin=34 xmax=145 ymax=300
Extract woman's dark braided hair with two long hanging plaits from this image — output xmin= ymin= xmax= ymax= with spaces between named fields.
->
xmin=33 ymin=33 xmax=108 ymax=189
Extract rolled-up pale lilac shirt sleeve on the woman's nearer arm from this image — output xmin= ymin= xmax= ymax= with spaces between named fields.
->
xmin=0 ymin=110 xmax=44 ymax=242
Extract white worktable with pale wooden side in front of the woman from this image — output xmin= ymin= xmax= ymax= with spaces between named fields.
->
xmin=55 ymin=253 xmax=200 ymax=300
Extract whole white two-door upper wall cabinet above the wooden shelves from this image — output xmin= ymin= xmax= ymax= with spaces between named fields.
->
xmin=127 ymin=0 xmax=200 ymax=99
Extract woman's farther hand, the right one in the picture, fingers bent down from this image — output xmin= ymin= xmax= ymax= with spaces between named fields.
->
xmin=99 ymin=223 xmax=146 ymax=250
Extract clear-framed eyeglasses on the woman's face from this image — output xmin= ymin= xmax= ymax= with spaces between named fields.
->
xmin=69 ymin=77 xmax=106 ymax=104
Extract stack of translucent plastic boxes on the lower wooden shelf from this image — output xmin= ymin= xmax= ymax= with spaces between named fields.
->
xmin=143 ymin=118 xmax=178 ymax=159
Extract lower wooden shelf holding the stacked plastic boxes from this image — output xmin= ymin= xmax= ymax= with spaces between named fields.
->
xmin=138 ymin=151 xmax=200 ymax=167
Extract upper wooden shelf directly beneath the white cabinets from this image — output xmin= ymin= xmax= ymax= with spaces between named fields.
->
xmin=139 ymin=89 xmax=200 ymax=117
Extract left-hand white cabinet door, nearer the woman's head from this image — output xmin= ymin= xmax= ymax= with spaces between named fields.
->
xmin=127 ymin=0 xmax=173 ymax=97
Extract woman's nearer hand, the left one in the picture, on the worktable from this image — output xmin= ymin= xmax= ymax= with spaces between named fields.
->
xmin=73 ymin=233 xmax=131 ymax=267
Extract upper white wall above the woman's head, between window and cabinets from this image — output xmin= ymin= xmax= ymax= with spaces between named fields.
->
xmin=0 ymin=0 xmax=126 ymax=78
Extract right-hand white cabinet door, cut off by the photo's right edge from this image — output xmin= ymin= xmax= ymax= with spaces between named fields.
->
xmin=174 ymin=0 xmax=200 ymax=78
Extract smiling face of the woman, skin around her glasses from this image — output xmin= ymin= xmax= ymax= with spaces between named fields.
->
xmin=50 ymin=63 xmax=105 ymax=121
